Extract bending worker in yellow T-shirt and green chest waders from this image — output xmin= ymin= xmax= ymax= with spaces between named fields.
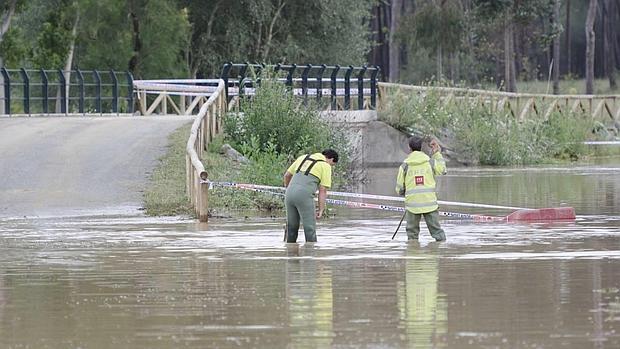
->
xmin=284 ymin=149 xmax=338 ymax=242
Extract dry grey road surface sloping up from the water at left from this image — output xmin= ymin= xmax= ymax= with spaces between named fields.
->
xmin=0 ymin=115 xmax=193 ymax=217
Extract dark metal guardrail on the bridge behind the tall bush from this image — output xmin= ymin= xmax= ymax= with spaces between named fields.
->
xmin=220 ymin=63 xmax=380 ymax=110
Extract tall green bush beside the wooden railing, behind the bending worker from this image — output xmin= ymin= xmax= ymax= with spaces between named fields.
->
xmin=224 ymin=79 xmax=350 ymax=186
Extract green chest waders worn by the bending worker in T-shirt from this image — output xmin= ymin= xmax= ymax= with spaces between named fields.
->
xmin=284 ymin=172 xmax=319 ymax=242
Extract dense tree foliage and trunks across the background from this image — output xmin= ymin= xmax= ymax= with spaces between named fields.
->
xmin=0 ymin=0 xmax=620 ymax=93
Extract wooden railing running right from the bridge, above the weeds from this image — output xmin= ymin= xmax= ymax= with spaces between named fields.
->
xmin=379 ymin=83 xmax=620 ymax=120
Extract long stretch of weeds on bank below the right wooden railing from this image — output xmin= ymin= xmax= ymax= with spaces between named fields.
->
xmin=379 ymin=92 xmax=594 ymax=165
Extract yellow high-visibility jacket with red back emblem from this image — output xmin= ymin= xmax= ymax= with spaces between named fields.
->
xmin=396 ymin=151 xmax=446 ymax=214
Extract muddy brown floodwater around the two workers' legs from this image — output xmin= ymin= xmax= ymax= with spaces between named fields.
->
xmin=0 ymin=159 xmax=620 ymax=348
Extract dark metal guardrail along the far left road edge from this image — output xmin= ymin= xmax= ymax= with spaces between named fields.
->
xmin=0 ymin=68 xmax=134 ymax=115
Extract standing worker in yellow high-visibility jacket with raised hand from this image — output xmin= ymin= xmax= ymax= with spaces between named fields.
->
xmin=396 ymin=136 xmax=446 ymax=241
